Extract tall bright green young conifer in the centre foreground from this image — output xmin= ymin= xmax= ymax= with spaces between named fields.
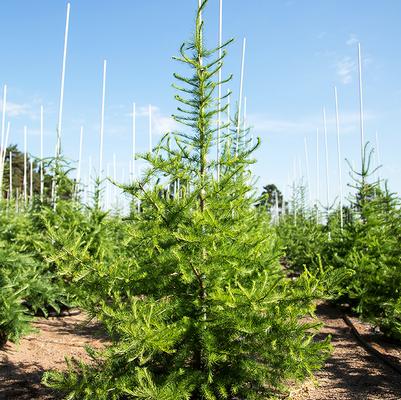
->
xmin=45 ymin=0 xmax=328 ymax=400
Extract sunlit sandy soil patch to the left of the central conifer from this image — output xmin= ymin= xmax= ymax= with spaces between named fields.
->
xmin=0 ymin=314 xmax=106 ymax=400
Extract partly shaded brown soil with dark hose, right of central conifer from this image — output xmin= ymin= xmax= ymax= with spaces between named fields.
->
xmin=291 ymin=304 xmax=401 ymax=400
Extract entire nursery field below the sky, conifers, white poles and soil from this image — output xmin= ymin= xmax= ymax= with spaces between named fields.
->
xmin=0 ymin=0 xmax=401 ymax=400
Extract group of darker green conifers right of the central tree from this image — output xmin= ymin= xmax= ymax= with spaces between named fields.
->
xmin=277 ymin=147 xmax=401 ymax=339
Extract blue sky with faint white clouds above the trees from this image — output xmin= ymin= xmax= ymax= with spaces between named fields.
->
xmin=0 ymin=0 xmax=401 ymax=202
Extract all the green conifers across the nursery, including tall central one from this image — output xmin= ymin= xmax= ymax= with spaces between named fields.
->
xmin=0 ymin=0 xmax=401 ymax=400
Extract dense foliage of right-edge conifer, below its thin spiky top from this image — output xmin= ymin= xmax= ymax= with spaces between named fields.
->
xmin=325 ymin=177 xmax=401 ymax=339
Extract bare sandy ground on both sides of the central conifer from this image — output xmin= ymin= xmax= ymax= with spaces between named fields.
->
xmin=0 ymin=304 xmax=401 ymax=400
